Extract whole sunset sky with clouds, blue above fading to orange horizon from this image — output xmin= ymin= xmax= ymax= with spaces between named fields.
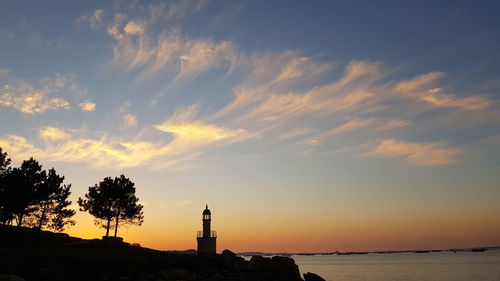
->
xmin=0 ymin=0 xmax=500 ymax=252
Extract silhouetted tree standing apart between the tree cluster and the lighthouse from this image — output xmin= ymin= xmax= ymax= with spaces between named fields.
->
xmin=78 ymin=175 xmax=144 ymax=237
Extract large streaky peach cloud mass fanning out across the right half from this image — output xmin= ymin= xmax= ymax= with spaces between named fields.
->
xmin=202 ymin=55 xmax=498 ymax=166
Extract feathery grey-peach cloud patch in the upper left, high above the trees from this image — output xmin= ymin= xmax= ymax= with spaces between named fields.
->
xmin=109 ymin=25 xmax=237 ymax=79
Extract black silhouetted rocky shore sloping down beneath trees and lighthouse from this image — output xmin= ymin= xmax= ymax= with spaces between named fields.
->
xmin=0 ymin=226 xmax=323 ymax=281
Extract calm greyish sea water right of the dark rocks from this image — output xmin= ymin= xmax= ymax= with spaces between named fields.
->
xmin=293 ymin=250 xmax=500 ymax=281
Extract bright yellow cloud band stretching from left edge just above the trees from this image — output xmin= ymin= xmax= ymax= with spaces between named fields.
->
xmin=0 ymin=107 xmax=250 ymax=170
